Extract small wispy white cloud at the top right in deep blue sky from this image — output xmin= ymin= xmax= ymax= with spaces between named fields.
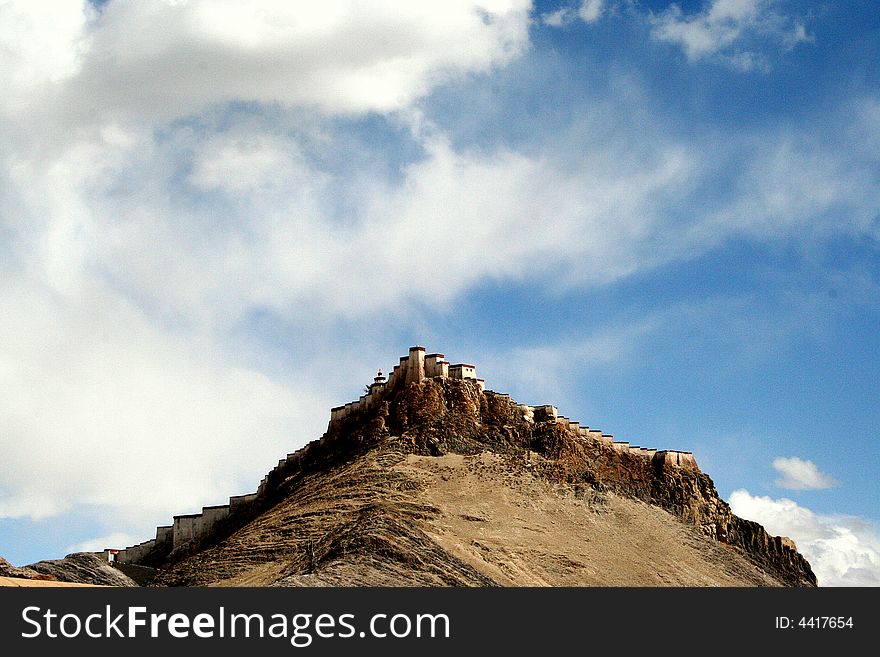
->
xmin=650 ymin=0 xmax=809 ymax=71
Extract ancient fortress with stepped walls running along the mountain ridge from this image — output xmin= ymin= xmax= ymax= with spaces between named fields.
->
xmin=104 ymin=346 xmax=699 ymax=564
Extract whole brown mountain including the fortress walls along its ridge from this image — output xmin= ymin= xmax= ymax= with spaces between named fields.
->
xmin=106 ymin=347 xmax=817 ymax=586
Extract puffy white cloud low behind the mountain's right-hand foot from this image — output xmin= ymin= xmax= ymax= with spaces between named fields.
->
xmin=730 ymin=489 xmax=880 ymax=586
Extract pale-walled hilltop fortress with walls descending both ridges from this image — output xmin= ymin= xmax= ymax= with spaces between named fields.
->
xmin=104 ymin=347 xmax=697 ymax=564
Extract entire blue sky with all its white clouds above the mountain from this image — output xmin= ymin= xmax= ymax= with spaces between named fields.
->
xmin=0 ymin=0 xmax=880 ymax=585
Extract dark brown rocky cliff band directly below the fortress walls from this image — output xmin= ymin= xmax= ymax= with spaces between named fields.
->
xmin=316 ymin=378 xmax=817 ymax=586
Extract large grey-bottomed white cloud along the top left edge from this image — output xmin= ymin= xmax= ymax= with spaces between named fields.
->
xmin=0 ymin=0 xmax=531 ymax=122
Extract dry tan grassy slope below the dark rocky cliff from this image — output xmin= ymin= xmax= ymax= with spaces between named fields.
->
xmin=156 ymin=443 xmax=779 ymax=586
